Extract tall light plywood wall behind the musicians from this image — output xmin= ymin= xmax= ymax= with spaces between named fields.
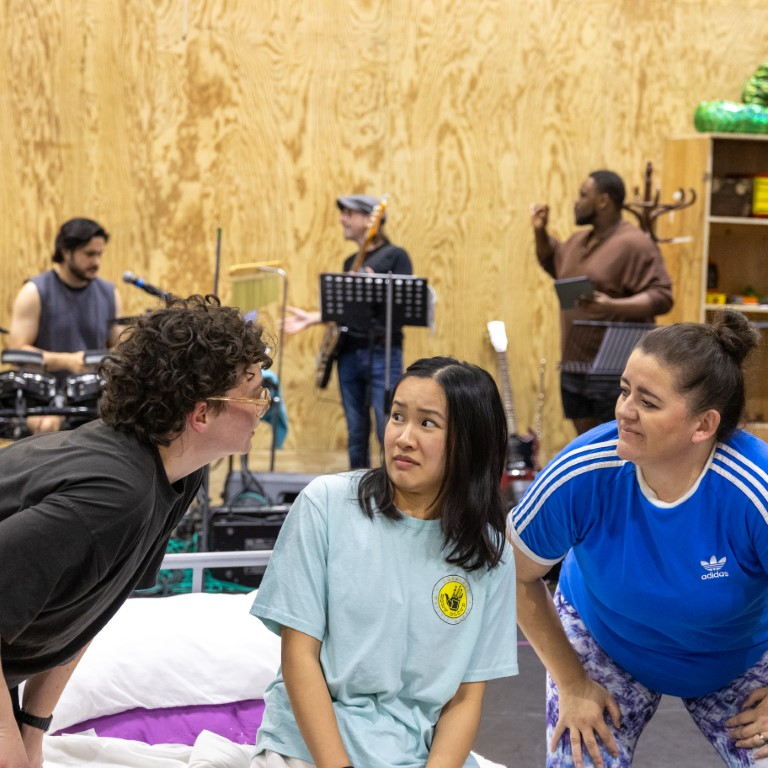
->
xmin=0 ymin=0 xmax=768 ymax=480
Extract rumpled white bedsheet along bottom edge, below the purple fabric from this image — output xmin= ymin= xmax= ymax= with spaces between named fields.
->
xmin=43 ymin=731 xmax=504 ymax=768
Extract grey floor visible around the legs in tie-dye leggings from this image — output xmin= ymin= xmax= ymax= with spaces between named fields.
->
xmin=474 ymin=645 xmax=723 ymax=768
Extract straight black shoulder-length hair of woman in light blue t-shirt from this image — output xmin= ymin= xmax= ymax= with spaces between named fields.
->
xmin=358 ymin=357 xmax=507 ymax=571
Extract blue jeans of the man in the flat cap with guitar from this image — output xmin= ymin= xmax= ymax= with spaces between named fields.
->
xmin=337 ymin=345 xmax=403 ymax=469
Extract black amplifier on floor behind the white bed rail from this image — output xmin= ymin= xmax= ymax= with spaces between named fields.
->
xmin=208 ymin=504 xmax=290 ymax=587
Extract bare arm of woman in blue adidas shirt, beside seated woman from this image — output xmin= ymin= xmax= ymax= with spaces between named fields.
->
xmin=510 ymin=541 xmax=621 ymax=768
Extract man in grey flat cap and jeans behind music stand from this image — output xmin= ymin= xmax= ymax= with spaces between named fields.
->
xmin=283 ymin=194 xmax=413 ymax=469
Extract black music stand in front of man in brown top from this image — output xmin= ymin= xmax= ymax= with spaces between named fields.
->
xmin=560 ymin=320 xmax=656 ymax=392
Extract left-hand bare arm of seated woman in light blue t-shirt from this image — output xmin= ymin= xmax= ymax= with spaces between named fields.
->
xmin=280 ymin=627 xmax=350 ymax=768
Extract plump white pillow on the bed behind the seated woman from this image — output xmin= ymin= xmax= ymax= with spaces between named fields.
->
xmin=51 ymin=592 xmax=280 ymax=731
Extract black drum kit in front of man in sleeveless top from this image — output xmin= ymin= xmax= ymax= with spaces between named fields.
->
xmin=0 ymin=349 xmax=105 ymax=439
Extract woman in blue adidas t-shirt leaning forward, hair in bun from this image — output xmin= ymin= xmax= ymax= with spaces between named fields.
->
xmin=508 ymin=310 xmax=768 ymax=768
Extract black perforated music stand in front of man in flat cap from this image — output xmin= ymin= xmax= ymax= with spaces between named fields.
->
xmin=320 ymin=272 xmax=433 ymax=410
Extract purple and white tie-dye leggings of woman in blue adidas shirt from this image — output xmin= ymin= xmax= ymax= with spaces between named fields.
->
xmin=547 ymin=590 xmax=768 ymax=768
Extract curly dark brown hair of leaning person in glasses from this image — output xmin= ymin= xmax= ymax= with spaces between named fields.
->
xmin=100 ymin=295 xmax=272 ymax=446
